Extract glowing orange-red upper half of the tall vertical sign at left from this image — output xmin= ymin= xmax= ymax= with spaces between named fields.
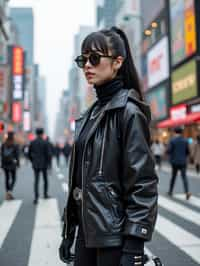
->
xmin=13 ymin=47 xmax=24 ymax=75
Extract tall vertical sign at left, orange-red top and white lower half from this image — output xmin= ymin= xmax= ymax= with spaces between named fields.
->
xmin=12 ymin=47 xmax=24 ymax=100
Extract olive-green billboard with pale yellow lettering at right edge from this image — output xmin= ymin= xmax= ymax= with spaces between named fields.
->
xmin=172 ymin=60 xmax=198 ymax=104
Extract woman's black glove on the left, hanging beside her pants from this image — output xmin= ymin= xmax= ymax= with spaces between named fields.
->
xmin=59 ymin=238 xmax=74 ymax=264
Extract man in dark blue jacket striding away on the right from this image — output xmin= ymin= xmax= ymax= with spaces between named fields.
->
xmin=168 ymin=127 xmax=191 ymax=200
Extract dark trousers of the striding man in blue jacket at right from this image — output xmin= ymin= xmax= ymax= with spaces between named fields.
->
xmin=169 ymin=164 xmax=189 ymax=194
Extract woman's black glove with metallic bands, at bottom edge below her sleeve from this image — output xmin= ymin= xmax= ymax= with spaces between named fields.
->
xmin=120 ymin=252 xmax=144 ymax=266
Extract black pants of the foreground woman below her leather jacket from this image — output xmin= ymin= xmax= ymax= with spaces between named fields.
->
xmin=74 ymin=225 xmax=122 ymax=266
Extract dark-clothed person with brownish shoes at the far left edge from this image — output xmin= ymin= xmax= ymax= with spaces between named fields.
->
xmin=1 ymin=131 xmax=19 ymax=200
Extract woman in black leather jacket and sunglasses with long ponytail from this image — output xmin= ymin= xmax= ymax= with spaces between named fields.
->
xmin=59 ymin=28 xmax=158 ymax=266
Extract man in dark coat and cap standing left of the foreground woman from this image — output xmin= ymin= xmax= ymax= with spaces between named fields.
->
xmin=29 ymin=128 xmax=51 ymax=204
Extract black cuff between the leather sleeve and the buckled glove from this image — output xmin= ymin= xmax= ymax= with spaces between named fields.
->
xmin=123 ymin=236 xmax=144 ymax=254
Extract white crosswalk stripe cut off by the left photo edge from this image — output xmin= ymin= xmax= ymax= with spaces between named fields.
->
xmin=0 ymin=200 xmax=22 ymax=248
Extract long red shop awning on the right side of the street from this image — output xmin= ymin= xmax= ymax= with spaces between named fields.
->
xmin=157 ymin=112 xmax=200 ymax=128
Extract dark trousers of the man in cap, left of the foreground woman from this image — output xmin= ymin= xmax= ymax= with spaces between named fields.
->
xmin=34 ymin=169 xmax=48 ymax=199
